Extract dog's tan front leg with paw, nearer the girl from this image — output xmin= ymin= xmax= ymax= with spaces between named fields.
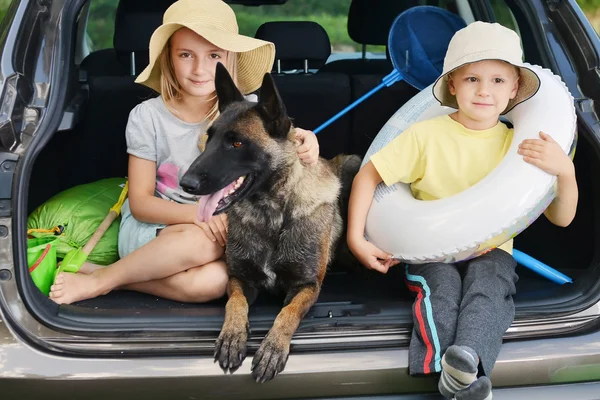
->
xmin=214 ymin=277 xmax=257 ymax=373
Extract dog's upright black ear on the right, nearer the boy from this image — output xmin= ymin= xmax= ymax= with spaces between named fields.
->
xmin=258 ymin=73 xmax=292 ymax=138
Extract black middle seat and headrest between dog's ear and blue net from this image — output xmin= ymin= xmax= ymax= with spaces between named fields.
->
xmin=256 ymin=21 xmax=351 ymax=158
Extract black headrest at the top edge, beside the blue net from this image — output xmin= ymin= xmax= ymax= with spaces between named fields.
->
xmin=348 ymin=0 xmax=419 ymax=46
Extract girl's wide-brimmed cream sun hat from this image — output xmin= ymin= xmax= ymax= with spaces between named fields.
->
xmin=135 ymin=0 xmax=275 ymax=94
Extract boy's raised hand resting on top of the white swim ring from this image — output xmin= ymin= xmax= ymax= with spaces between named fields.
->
xmin=518 ymin=132 xmax=575 ymax=176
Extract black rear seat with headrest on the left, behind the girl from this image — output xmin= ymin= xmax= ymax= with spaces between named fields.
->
xmin=62 ymin=0 xmax=173 ymax=188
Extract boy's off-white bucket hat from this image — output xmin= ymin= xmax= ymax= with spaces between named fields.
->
xmin=433 ymin=21 xmax=540 ymax=114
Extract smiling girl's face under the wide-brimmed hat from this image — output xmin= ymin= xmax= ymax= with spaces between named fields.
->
xmin=171 ymin=28 xmax=228 ymax=97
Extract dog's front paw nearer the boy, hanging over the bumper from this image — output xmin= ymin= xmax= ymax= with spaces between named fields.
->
xmin=252 ymin=330 xmax=290 ymax=383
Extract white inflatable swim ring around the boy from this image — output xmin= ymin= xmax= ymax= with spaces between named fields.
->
xmin=363 ymin=65 xmax=577 ymax=264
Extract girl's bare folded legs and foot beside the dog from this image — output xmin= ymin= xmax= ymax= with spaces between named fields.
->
xmin=50 ymin=224 xmax=228 ymax=304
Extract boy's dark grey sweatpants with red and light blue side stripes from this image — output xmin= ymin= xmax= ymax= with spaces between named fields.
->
xmin=406 ymin=249 xmax=519 ymax=376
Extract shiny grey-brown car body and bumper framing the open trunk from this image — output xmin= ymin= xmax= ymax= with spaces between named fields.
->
xmin=0 ymin=0 xmax=600 ymax=400
